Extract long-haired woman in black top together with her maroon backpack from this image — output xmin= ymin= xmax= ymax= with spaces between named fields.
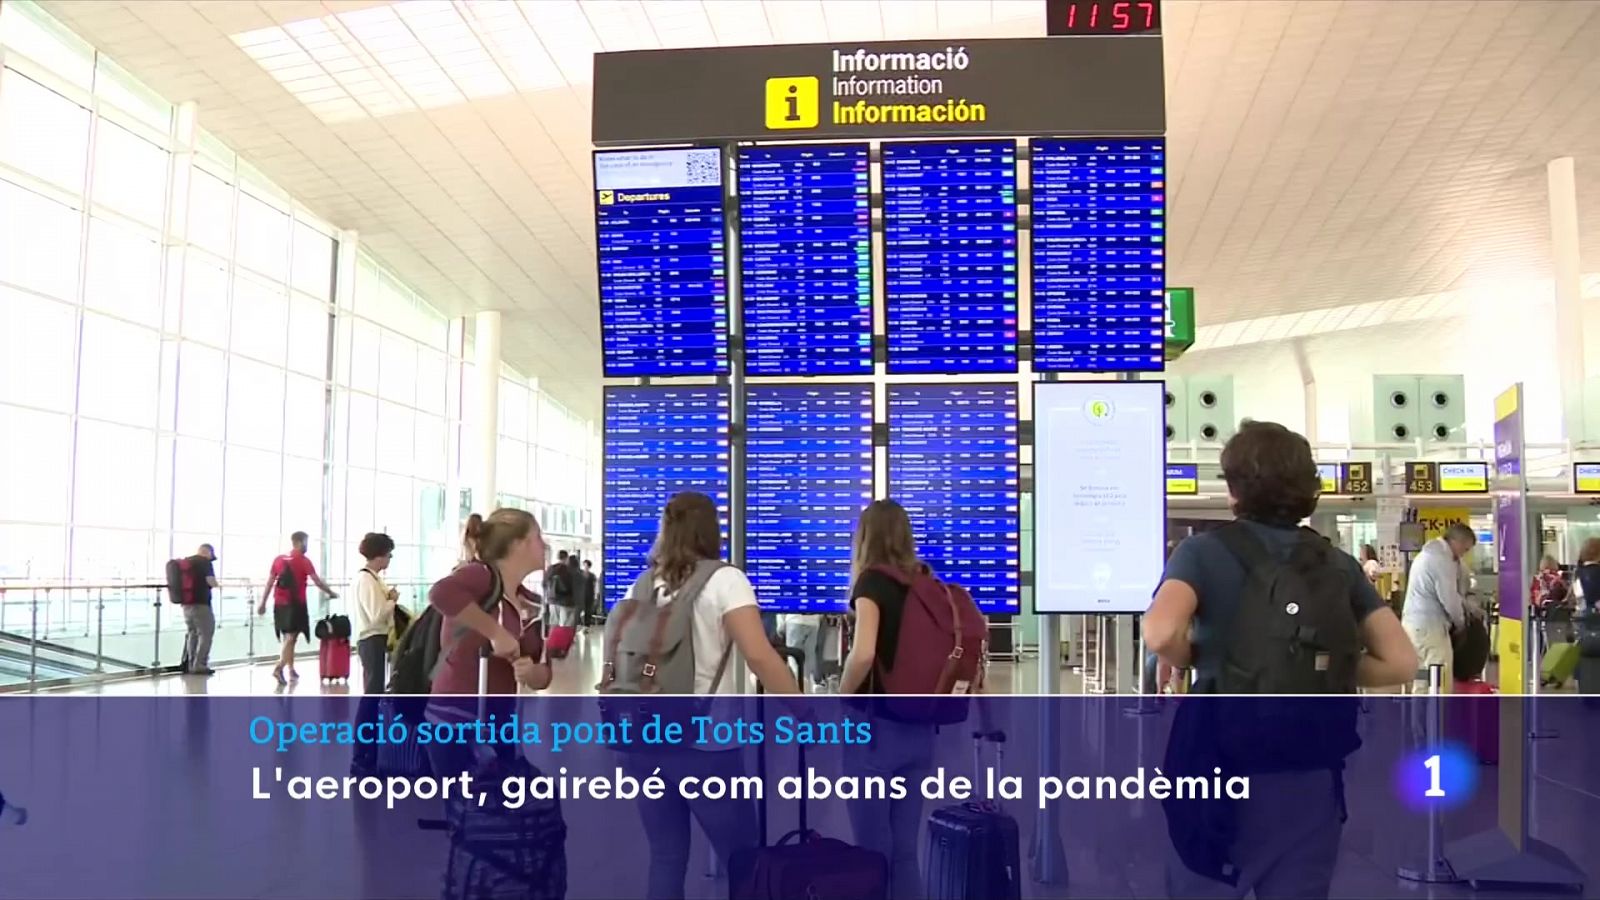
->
xmin=838 ymin=500 xmax=989 ymax=897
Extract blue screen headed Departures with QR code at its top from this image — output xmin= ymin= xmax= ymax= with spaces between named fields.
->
xmin=595 ymin=147 xmax=728 ymax=376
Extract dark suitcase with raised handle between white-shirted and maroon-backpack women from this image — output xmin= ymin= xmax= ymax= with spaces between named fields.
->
xmin=728 ymin=647 xmax=890 ymax=900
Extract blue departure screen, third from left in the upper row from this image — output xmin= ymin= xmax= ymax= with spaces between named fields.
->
xmin=883 ymin=141 xmax=1018 ymax=375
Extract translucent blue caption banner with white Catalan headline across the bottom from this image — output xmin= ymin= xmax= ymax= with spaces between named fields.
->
xmin=0 ymin=697 xmax=1600 ymax=900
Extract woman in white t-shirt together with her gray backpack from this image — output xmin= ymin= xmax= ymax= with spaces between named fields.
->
xmin=597 ymin=492 xmax=800 ymax=900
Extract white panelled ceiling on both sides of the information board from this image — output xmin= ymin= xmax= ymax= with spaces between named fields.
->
xmin=34 ymin=0 xmax=1600 ymax=415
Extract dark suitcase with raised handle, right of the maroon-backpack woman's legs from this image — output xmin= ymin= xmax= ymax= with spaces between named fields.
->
xmin=922 ymin=732 xmax=1022 ymax=900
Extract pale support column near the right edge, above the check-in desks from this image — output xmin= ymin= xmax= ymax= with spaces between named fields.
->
xmin=1546 ymin=157 xmax=1580 ymax=442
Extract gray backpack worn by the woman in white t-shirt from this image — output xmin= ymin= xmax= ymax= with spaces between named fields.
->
xmin=595 ymin=559 xmax=733 ymax=693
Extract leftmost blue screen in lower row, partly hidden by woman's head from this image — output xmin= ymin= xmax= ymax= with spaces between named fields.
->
xmin=602 ymin=386 xmax=731 ymax=607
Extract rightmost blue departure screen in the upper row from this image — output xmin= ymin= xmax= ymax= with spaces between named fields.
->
xmin=1029 ymin=138 xmax=1166 ymax=372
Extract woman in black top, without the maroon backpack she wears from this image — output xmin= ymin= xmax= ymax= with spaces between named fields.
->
xmin=840 ymin=500 xmax=934 ymax=897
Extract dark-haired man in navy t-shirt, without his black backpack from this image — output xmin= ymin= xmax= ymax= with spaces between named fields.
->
xmin=1141 ymin=423 xmax=1416 ymax=897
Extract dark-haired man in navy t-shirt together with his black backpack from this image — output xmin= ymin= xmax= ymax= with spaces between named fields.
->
xmin=1141 ymin=421 xmax=1414 ymax=897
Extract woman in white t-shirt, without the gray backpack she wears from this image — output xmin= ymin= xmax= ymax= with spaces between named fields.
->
xmin=624 ymin=492 xmax=800 ymax=898
